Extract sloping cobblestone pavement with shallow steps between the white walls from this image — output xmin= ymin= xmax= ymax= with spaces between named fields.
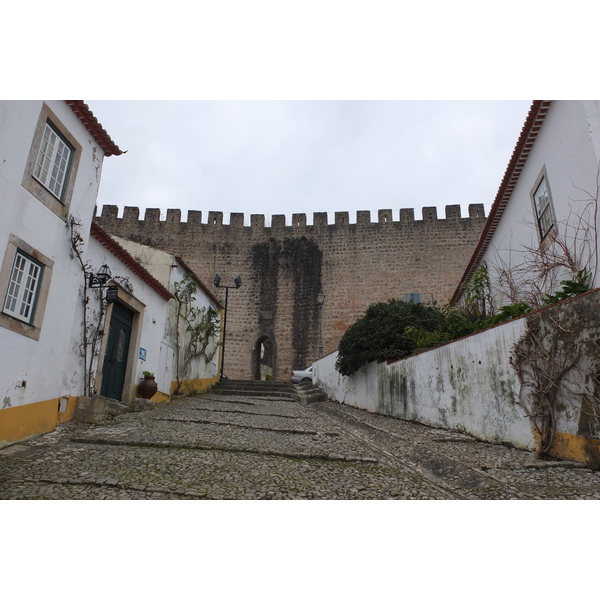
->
xmin=0 ymin=394 xmax=600 ymax=500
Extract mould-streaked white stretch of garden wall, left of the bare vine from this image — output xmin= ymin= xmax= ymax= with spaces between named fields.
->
xmin=314 ymin=319 xmax=534 ymax=450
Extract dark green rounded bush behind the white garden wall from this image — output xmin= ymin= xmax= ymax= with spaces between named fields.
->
xmin=335 ymin=300 xmax=444 ymax=375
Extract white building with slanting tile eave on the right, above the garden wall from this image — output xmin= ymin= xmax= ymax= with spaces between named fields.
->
xmin=452 ymin=100 xmax=600 ymax=306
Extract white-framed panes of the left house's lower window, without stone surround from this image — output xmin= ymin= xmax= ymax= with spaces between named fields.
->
xmin=3 ymin=252 xmax=43 ymax=323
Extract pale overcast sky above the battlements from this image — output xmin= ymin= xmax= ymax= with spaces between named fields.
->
xmin=86 ymin=100 xmax=531 ymax=224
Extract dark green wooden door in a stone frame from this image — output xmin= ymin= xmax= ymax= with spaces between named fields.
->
xmin=100 ymin=302 xmax=133 ymax=400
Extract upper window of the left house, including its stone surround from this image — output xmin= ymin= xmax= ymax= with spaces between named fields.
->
xmin=22 ymin=103 xmax=82 ymax=222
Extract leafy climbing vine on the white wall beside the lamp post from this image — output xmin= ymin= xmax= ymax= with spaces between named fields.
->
xmin=174 ymin=273 xmax=220 ymax=393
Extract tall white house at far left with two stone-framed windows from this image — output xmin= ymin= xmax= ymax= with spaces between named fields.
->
xmin=0 ymin=101 xmax=122 ymax=445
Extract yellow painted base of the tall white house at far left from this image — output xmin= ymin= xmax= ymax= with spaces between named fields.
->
xmin=0 ymin=396 xmax=77 ymax=447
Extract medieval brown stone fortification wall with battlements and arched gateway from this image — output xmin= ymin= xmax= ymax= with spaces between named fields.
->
xmin=95 ymin=204 xmax=485 ymax=380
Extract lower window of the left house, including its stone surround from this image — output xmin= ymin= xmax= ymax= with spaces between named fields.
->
xmin=0 ymin=233 xmax=54 ymax=340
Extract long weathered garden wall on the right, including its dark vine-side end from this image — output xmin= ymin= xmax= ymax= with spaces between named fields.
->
xmin=314 ymin=290 xmax=600 ymax=469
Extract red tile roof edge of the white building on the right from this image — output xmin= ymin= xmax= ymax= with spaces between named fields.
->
xmin=450 ymin=100 xmax=550 ymax=304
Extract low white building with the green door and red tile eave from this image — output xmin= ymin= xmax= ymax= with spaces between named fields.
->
xmin=85 ymin=223 xmax=173 ymax=404
